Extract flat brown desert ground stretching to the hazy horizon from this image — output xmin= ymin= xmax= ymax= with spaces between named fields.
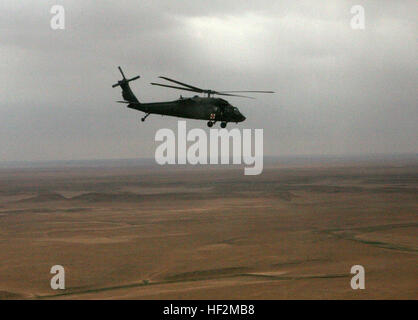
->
xmin=0 ymin=162 xmax=418 ymax=299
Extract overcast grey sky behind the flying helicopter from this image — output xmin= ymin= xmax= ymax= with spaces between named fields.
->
xmin=0 ymin=0 xmax=418 ymax=161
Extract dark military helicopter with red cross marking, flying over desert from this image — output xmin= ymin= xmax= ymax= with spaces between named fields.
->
xmin=112 ymin=67 xmax=274 ymax=128
